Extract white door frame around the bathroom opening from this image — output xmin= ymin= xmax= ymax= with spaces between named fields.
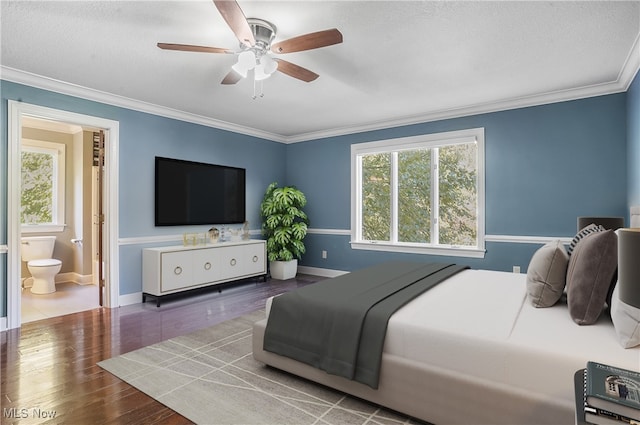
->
xmin=7 ymin=100 xmax=120 ymax=329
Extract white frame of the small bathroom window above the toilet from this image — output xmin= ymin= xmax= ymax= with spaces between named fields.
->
xmin=20 ymin=139 xmax=66 ymax=233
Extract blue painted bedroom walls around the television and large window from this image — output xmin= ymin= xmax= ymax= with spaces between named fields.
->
xmin=0 ymin=77 xmax=640 ymax=317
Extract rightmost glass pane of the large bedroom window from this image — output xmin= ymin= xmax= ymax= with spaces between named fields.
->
xmin=439 ymin=143 xmax=478 ymax=246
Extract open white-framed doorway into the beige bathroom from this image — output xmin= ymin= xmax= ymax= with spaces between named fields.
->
xmin=7 ymin=101 xmax=119 ymax=328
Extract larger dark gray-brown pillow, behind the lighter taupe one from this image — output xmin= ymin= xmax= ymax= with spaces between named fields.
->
xmin=567 ymin=230 xmax=618 ymax=325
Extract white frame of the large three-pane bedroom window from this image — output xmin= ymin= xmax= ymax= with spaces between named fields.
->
xmin=351 ymin=128 xmax=485 ymax=258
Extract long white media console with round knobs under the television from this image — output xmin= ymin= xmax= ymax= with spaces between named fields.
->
xmin=142 ymin=239 xmax=267 ymax=307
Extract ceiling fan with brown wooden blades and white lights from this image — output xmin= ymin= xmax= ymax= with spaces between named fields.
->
xmin=158 ymin=0 xmax=342 ymax=84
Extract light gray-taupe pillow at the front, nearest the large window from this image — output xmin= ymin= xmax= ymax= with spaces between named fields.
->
xmin=527 ymin=240 xmax=569 ymax=307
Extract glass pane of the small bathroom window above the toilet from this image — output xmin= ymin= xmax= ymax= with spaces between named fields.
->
xmin=20 ymin=151 xmax=54 ymax=224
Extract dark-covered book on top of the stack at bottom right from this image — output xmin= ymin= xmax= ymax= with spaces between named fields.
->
xmin=585 ymin=362 xmax=640 ymax=423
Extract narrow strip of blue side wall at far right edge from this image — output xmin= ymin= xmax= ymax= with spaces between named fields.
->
xmin=627 ymin=73 xmax=640 ymax=206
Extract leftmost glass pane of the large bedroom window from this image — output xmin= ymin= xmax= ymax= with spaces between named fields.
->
xmin=362 ymin=153 xmax=391 ymax=241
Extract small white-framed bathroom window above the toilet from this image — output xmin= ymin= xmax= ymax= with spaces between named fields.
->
xmin=20 ymin=139 xmax=65 ymax=232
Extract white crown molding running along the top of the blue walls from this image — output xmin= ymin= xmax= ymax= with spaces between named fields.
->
xmin=0 ymin=34 xmax=640 ymax=144
